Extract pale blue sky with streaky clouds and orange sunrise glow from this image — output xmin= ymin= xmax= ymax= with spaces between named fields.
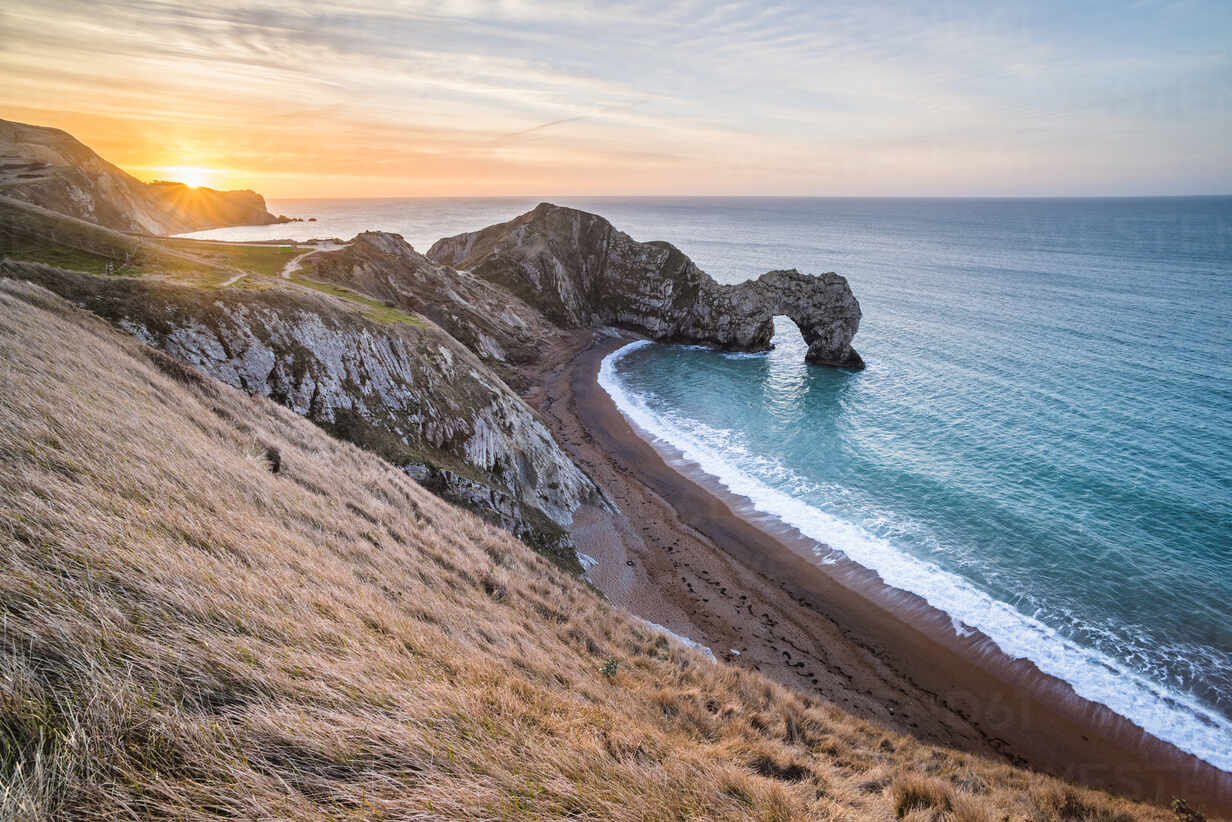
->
xmin=0 ymin=0 xmax=1232 ymax=198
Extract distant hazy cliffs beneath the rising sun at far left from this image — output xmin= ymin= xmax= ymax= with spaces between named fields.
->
xmin=0 ymin=120 xmax=278 ymax=234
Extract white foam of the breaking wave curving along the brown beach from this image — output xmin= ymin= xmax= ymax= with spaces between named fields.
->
xmin=599 ymin=340 xmax=1232 ymax=770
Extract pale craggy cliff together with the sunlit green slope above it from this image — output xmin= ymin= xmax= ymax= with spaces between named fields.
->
xmin=0 ymin=197 xmax=601 ymax=569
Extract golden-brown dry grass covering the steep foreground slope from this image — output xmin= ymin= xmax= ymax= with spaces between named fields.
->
xmin=0 ymin=281 xmax=1212 ymax=822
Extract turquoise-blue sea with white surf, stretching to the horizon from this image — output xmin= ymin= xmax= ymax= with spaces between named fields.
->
xmin=182 ymin=197 xmax=1232 ymax=770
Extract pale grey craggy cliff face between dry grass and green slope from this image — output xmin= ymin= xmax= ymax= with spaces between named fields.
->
xmin=0 ymin=261 xmax=606 ymax=564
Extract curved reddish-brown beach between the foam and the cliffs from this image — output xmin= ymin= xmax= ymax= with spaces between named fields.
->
xmin=527 ymin=330 xmax=1232 ymax=815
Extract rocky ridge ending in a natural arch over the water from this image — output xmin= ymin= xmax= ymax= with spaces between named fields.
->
xmin=428 ymin=203 xmax=864 ymax=368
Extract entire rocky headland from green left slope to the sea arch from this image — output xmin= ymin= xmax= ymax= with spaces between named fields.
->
xmin=0 ymin=182 xmax=861 ymax=568
